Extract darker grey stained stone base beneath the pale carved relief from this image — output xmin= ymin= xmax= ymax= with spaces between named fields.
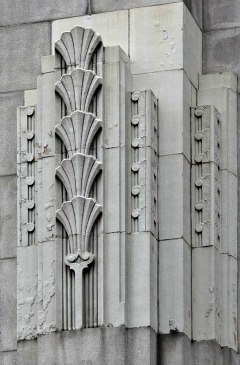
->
xmin=15 ymin=327 xmax=240 ymax=365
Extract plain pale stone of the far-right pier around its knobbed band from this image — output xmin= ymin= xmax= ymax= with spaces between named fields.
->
xmin=192 ymin=73 xmax=238 ymax=350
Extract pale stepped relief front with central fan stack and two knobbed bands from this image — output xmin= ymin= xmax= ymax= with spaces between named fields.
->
xmin=18 ymin=27 xmax=158 ymax=340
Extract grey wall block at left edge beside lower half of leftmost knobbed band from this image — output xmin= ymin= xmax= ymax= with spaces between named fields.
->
xmin=0 ymin=176 xmax=17 ymax=259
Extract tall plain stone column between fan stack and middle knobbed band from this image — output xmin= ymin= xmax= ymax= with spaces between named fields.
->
xmin=104 ymin=46 xmax=132 ymax=326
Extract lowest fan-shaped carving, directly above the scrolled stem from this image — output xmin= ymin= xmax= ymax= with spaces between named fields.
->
xmin=56 ymin=196 xmax=102 ymax=253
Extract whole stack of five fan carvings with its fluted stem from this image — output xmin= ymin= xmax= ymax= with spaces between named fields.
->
xmin=55 ymin=27 xmax=102 ymax=330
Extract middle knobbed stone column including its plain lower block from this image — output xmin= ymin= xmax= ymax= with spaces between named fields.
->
xmin=126 ymin=90 xmax=159 ymax=332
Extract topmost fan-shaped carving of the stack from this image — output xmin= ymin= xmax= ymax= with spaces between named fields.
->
xmin=55 ymin=27 xmax=102 ymax=70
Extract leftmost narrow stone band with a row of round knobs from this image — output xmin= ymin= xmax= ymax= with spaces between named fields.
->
xmin=18 ymin=106 xmax=36 ymax=246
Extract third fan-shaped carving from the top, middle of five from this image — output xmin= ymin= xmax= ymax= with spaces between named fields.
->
xmin=56 ymin=110 xmax=102 ymax=156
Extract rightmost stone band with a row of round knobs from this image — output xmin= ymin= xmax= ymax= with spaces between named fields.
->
xmin=192 ymin=106 xmax=221 ymax=247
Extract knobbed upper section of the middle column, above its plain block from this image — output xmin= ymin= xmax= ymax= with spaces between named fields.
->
xmin=131 ymin=90 xmax=158 ymax=237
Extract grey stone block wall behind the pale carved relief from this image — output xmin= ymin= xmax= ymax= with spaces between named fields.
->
xmin=0 ymin=0 xmax=240 ymax=365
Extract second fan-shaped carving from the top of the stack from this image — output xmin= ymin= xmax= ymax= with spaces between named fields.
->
xmin=56 ymin=68 xmax=102 ymax=115
